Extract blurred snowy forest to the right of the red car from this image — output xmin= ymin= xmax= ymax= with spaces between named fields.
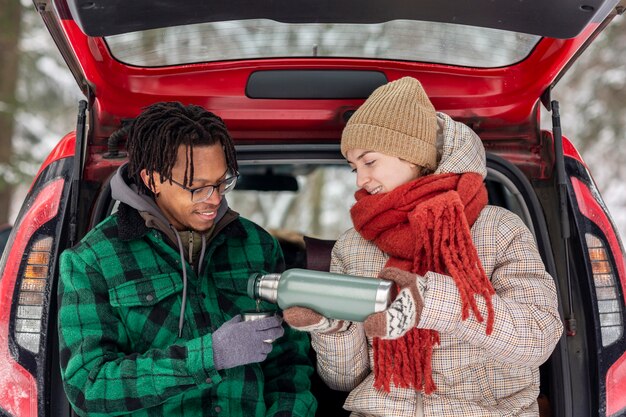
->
xmin=554 ymin=15 xmax=626 ymax=238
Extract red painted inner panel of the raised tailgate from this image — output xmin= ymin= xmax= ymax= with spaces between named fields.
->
xmin=45 ymin=0 xmax=614 ymax=152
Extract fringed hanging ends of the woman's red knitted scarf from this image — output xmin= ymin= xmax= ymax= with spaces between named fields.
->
xmin=355 ymin=173 xmax=495 ymax=394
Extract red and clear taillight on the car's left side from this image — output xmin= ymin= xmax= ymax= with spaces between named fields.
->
xmin=0 ymin=178 xmax=65 ymax=417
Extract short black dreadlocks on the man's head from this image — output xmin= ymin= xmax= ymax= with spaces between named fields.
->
xmin=126 ymin=102 xmax=238 ymax=193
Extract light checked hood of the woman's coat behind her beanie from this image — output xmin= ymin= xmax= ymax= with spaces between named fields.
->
xmin=435 ymin=113 xmax=487 ymax=178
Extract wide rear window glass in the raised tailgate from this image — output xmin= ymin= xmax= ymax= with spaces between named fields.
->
xmin=105 ymin=19 xmax=541 ymax=68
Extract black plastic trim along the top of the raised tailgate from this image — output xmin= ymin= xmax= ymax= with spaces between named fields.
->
xmin=67 ymin=0 xmax=618 ymax=38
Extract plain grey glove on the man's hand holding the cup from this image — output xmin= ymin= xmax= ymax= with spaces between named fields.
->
xmin=213 ymin=315 xmax=285 ymax=370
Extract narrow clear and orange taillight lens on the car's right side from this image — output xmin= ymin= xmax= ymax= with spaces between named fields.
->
xmin=585 ymin=233 xmax=624 ymax=347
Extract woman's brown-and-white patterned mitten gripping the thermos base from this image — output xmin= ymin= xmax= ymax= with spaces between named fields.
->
xmin=363 ymin=267 xmax=424 ymax=339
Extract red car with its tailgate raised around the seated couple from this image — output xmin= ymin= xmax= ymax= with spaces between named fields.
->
xmin=0 ymin=0 xmax=626 ymax=417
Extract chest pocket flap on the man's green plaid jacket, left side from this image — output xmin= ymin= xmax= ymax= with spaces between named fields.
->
xmin=109 ymin=274 xmax=183 ymax=308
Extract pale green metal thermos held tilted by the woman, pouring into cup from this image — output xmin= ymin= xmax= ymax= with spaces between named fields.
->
xmin=248 ymin=268 xmax=395 ymax=322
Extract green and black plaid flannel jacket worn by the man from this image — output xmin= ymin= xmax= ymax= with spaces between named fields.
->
xmin=58 ymin=205 xmax=317 ymax=417
